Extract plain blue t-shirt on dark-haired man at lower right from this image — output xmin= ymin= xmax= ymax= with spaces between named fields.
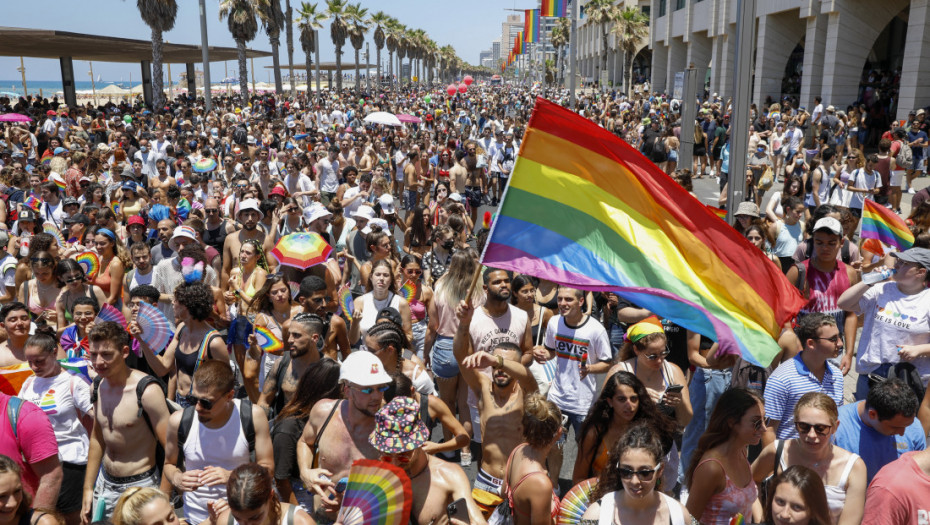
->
xmin=833 ymin=401 xmax=927 ymax=483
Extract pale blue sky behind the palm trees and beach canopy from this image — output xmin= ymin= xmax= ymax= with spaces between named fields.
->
xmin=0 ymin=0 xmax=520 ymax=84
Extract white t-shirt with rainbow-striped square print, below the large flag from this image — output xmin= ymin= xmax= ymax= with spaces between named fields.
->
xmin=545 ymin=315 xmax=613 ymax=415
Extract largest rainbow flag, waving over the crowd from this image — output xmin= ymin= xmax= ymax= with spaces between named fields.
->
xmin=482 ymin=99 xmax=804 ymax=366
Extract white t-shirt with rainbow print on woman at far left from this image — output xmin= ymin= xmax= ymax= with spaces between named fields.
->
xmin=19 ymin=370 xmax=94 ymax=465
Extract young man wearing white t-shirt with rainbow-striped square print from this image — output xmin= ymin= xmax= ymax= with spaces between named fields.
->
xmin=534 ymin=286 xmax=613 ymax=485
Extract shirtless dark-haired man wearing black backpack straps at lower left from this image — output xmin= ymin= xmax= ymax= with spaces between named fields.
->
xmin=81 ymin=322 xmax=168 ymax=525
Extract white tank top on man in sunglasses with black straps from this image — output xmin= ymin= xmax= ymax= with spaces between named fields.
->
xmin=184 ymin=399 xmax=249 ymax=521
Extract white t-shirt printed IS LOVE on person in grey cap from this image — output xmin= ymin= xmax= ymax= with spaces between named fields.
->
xmin=856 ymin=281 xmax=930 ymax=384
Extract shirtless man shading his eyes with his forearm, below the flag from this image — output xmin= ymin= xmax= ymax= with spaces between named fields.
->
xmin=452 ymin=301 xmax=539 ymax=501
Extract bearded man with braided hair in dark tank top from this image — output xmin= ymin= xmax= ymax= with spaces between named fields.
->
xmin=258 ymin=314 xmax=323 ymax=414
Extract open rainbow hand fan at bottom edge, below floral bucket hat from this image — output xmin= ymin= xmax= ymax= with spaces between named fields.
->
xmin=336 ymin=459 xmax=413 ymax=525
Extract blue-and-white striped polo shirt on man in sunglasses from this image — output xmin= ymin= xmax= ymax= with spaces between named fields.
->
xmin=764 ymin=352 xmax=843 ymax=439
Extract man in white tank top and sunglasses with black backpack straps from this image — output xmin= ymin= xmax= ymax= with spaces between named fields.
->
xmin=163 ymin=359 xmax=274 ymax=523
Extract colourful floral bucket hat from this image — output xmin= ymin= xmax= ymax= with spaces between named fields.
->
xmin=368 ymin=396 xmax=429 ymax=454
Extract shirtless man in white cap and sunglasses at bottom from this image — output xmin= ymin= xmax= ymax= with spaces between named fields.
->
xmin=297 ymin=352 xmax=386 ymax=524
